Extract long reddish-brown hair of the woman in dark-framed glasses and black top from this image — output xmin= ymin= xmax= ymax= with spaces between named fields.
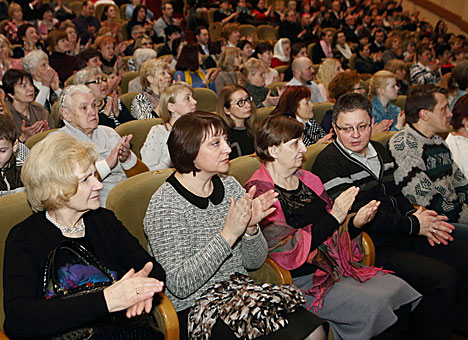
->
xmin=216 ymin=84 xmax=257 ymax=137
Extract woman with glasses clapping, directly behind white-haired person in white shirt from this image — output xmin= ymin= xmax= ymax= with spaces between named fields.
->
xmin=73 ymin=67 xmax=134 ymax=128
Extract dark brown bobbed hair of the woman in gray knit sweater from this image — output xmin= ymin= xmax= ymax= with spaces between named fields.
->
xmin=167 ymin=111 xmax=228 ymax=174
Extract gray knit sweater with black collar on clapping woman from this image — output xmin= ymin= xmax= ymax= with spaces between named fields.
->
xmin=144 ymin=177 xmax=268 ymax=311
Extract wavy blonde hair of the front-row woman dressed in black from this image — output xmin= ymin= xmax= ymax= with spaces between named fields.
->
xmin=21 ymin=132 xmax=98 ymax=212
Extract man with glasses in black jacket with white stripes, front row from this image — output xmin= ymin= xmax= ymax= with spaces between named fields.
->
xmin=312 ymin=93 xmax=468 ymax=340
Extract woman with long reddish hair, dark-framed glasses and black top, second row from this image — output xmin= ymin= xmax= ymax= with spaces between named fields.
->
xmin=216 ymin=84 xmax=257 ymax=159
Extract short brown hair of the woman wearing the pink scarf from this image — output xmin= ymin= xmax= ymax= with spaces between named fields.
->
xmin=255 ymin=116 xmax=304 ymax=162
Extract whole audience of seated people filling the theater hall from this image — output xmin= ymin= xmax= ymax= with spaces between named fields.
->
xmin=0 ymin=0 xmax=468 ymax=340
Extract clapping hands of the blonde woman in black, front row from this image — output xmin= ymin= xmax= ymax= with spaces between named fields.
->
xmin=104 ymin=266 xmax=164 ymax=317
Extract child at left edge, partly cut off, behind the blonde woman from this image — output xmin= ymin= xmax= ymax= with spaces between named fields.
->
xmin=0 ymin=114 xmax=24 ymax=197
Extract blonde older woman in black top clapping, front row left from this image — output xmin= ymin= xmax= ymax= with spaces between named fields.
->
xmin=3 ymin=133 xmax=165 ymax=338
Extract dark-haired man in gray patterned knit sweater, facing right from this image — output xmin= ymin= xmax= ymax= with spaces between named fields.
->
xmin=389 ymin=85 xmax=468 ymax=224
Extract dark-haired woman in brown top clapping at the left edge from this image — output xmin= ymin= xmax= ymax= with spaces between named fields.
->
xmin=3 ymin=70 xmax=55 ymax=142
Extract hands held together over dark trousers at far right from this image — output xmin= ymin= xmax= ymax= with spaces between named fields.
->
xmin=413 ymin=207 xmax=455 ymax=246
